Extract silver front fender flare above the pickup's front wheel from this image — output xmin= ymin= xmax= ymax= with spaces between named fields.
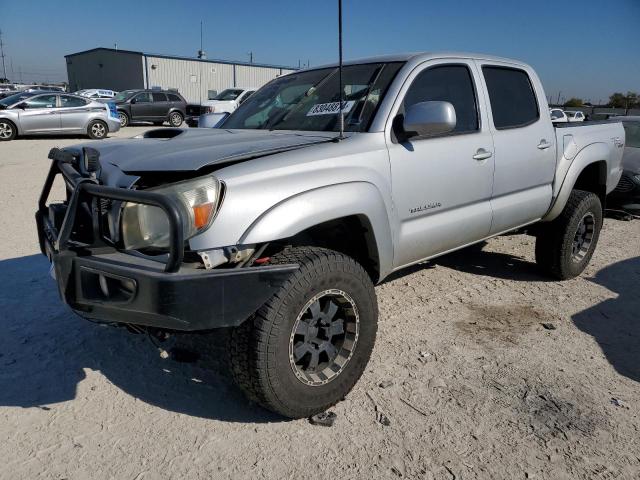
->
xmin=239 ymin=182 xmax=393 ymax=280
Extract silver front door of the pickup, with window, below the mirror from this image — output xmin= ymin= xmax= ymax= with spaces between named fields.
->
xmin=387 ymin=59 xmax=494 ymax=268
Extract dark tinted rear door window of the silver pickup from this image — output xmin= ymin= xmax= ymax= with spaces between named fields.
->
xmin=482 ymin=67 xmax=540 ymax=129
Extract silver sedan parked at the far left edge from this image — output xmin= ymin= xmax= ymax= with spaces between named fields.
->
xmin=0 ymin=92 xmax=120 ymax=141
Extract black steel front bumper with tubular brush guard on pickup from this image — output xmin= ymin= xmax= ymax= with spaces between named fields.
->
xmin=36 ymin=148 xmax=298 ymax=331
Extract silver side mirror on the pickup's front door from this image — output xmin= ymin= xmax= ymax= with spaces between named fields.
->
xmin=402 ymin=101 xmax=456 ymax=138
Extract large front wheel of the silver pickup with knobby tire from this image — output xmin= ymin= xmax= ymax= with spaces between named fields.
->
xmin=228 ymin=247 xmax=378 ymax=418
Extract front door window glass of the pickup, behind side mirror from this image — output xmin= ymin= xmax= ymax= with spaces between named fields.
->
xmin=402 ymin=65 xmax=479 ymax=133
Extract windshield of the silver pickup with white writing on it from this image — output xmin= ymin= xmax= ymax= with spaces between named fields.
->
xmin=222 ymin=62 xmax=403 ymax=132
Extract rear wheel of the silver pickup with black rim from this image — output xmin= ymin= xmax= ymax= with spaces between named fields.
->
xmin=536 ymin=190 xmax=602 ymax=280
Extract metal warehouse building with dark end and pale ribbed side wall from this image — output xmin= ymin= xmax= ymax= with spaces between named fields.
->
xmin=65 ymin=48 xmax=295 ymax=102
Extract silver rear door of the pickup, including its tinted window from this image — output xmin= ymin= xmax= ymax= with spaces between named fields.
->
xmin=477 ymin=61 xmax=556 ymax=234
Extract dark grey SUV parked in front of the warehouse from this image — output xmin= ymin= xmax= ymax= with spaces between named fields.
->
xmin=112 ymin=90 xmax=187 ymax=127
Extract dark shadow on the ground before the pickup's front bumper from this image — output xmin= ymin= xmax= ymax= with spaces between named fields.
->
xmin=0 ymin=255 xmax=283 ymax=422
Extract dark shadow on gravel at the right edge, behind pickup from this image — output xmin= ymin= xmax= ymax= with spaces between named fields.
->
xmin=572 ymin=257 xmax=640 ymax=382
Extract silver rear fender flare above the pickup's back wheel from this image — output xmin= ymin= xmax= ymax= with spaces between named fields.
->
xmin=542 ymin=142 xmax=615 ymax=222
